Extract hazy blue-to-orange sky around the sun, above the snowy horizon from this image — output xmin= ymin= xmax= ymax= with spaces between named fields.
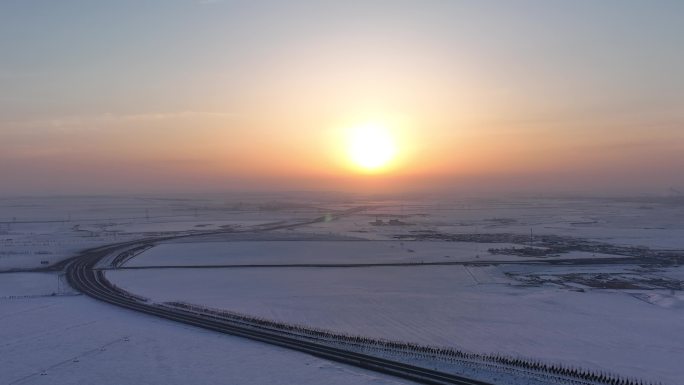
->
xmin=0 ymin=0 xmax=684 ymax=194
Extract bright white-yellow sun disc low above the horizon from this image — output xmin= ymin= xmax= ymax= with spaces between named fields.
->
xmin=349 ymin=124 xmax=397 ymax=172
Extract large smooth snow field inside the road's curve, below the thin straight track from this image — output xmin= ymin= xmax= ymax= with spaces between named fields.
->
xmin=107 ymin=260 xmax=684 ymax=384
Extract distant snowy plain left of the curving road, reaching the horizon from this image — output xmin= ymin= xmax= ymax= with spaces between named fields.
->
xmin=0 ymin=194 xmax=337 ymax=271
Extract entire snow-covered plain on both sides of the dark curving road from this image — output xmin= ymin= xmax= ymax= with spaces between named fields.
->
xmin=0 ymin=194 xmax=684 ymax=385
